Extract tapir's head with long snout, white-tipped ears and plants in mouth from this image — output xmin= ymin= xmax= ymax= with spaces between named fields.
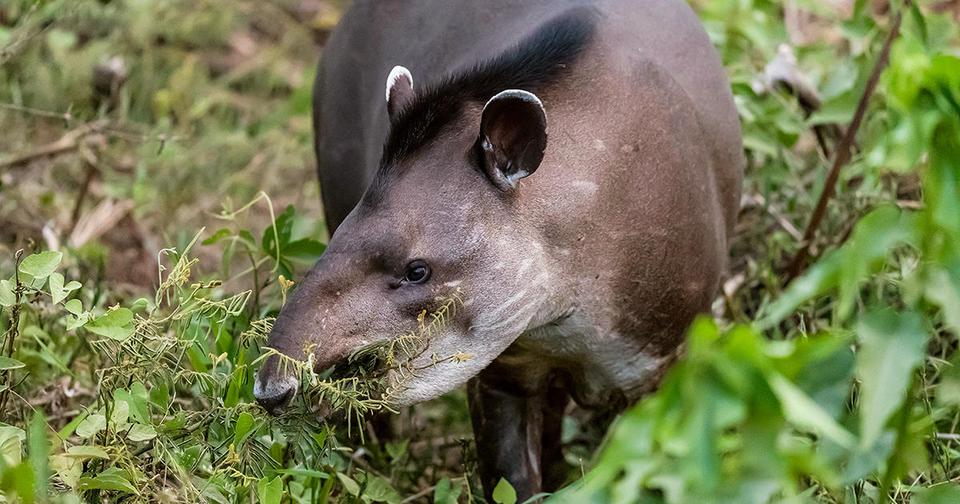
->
xmin=254 ymin=67 xmax=549 ymax=410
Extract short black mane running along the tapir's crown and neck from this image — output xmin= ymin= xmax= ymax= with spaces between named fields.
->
xmin=378 ymin=8 xmax=595 ymax=169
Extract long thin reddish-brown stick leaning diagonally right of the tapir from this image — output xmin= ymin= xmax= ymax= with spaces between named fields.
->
xmin=784 ymin=4 xmax=910 ymax=284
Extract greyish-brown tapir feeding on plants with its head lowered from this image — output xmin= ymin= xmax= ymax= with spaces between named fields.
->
xmin=254 ymin=0 xmax=744 ymax=501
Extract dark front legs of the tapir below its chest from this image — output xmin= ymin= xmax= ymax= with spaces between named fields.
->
xmin=467 ymin=369 xmax=567 ymax=502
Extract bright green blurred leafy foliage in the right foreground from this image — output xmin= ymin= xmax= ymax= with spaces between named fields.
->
xmin=556 ymin=2 xmax=960 ymax=503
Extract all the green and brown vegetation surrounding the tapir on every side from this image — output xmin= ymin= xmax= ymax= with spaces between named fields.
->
xmin=0 ymin=0 xmax=960 ymax=503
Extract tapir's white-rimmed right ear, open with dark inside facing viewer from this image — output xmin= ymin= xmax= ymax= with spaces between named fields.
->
xmin=477 ymin=89 xmax=547 ymax=190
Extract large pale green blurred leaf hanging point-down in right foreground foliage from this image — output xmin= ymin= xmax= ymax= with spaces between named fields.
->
xmin=857 ymin=311 xmax=927 ymax=447
